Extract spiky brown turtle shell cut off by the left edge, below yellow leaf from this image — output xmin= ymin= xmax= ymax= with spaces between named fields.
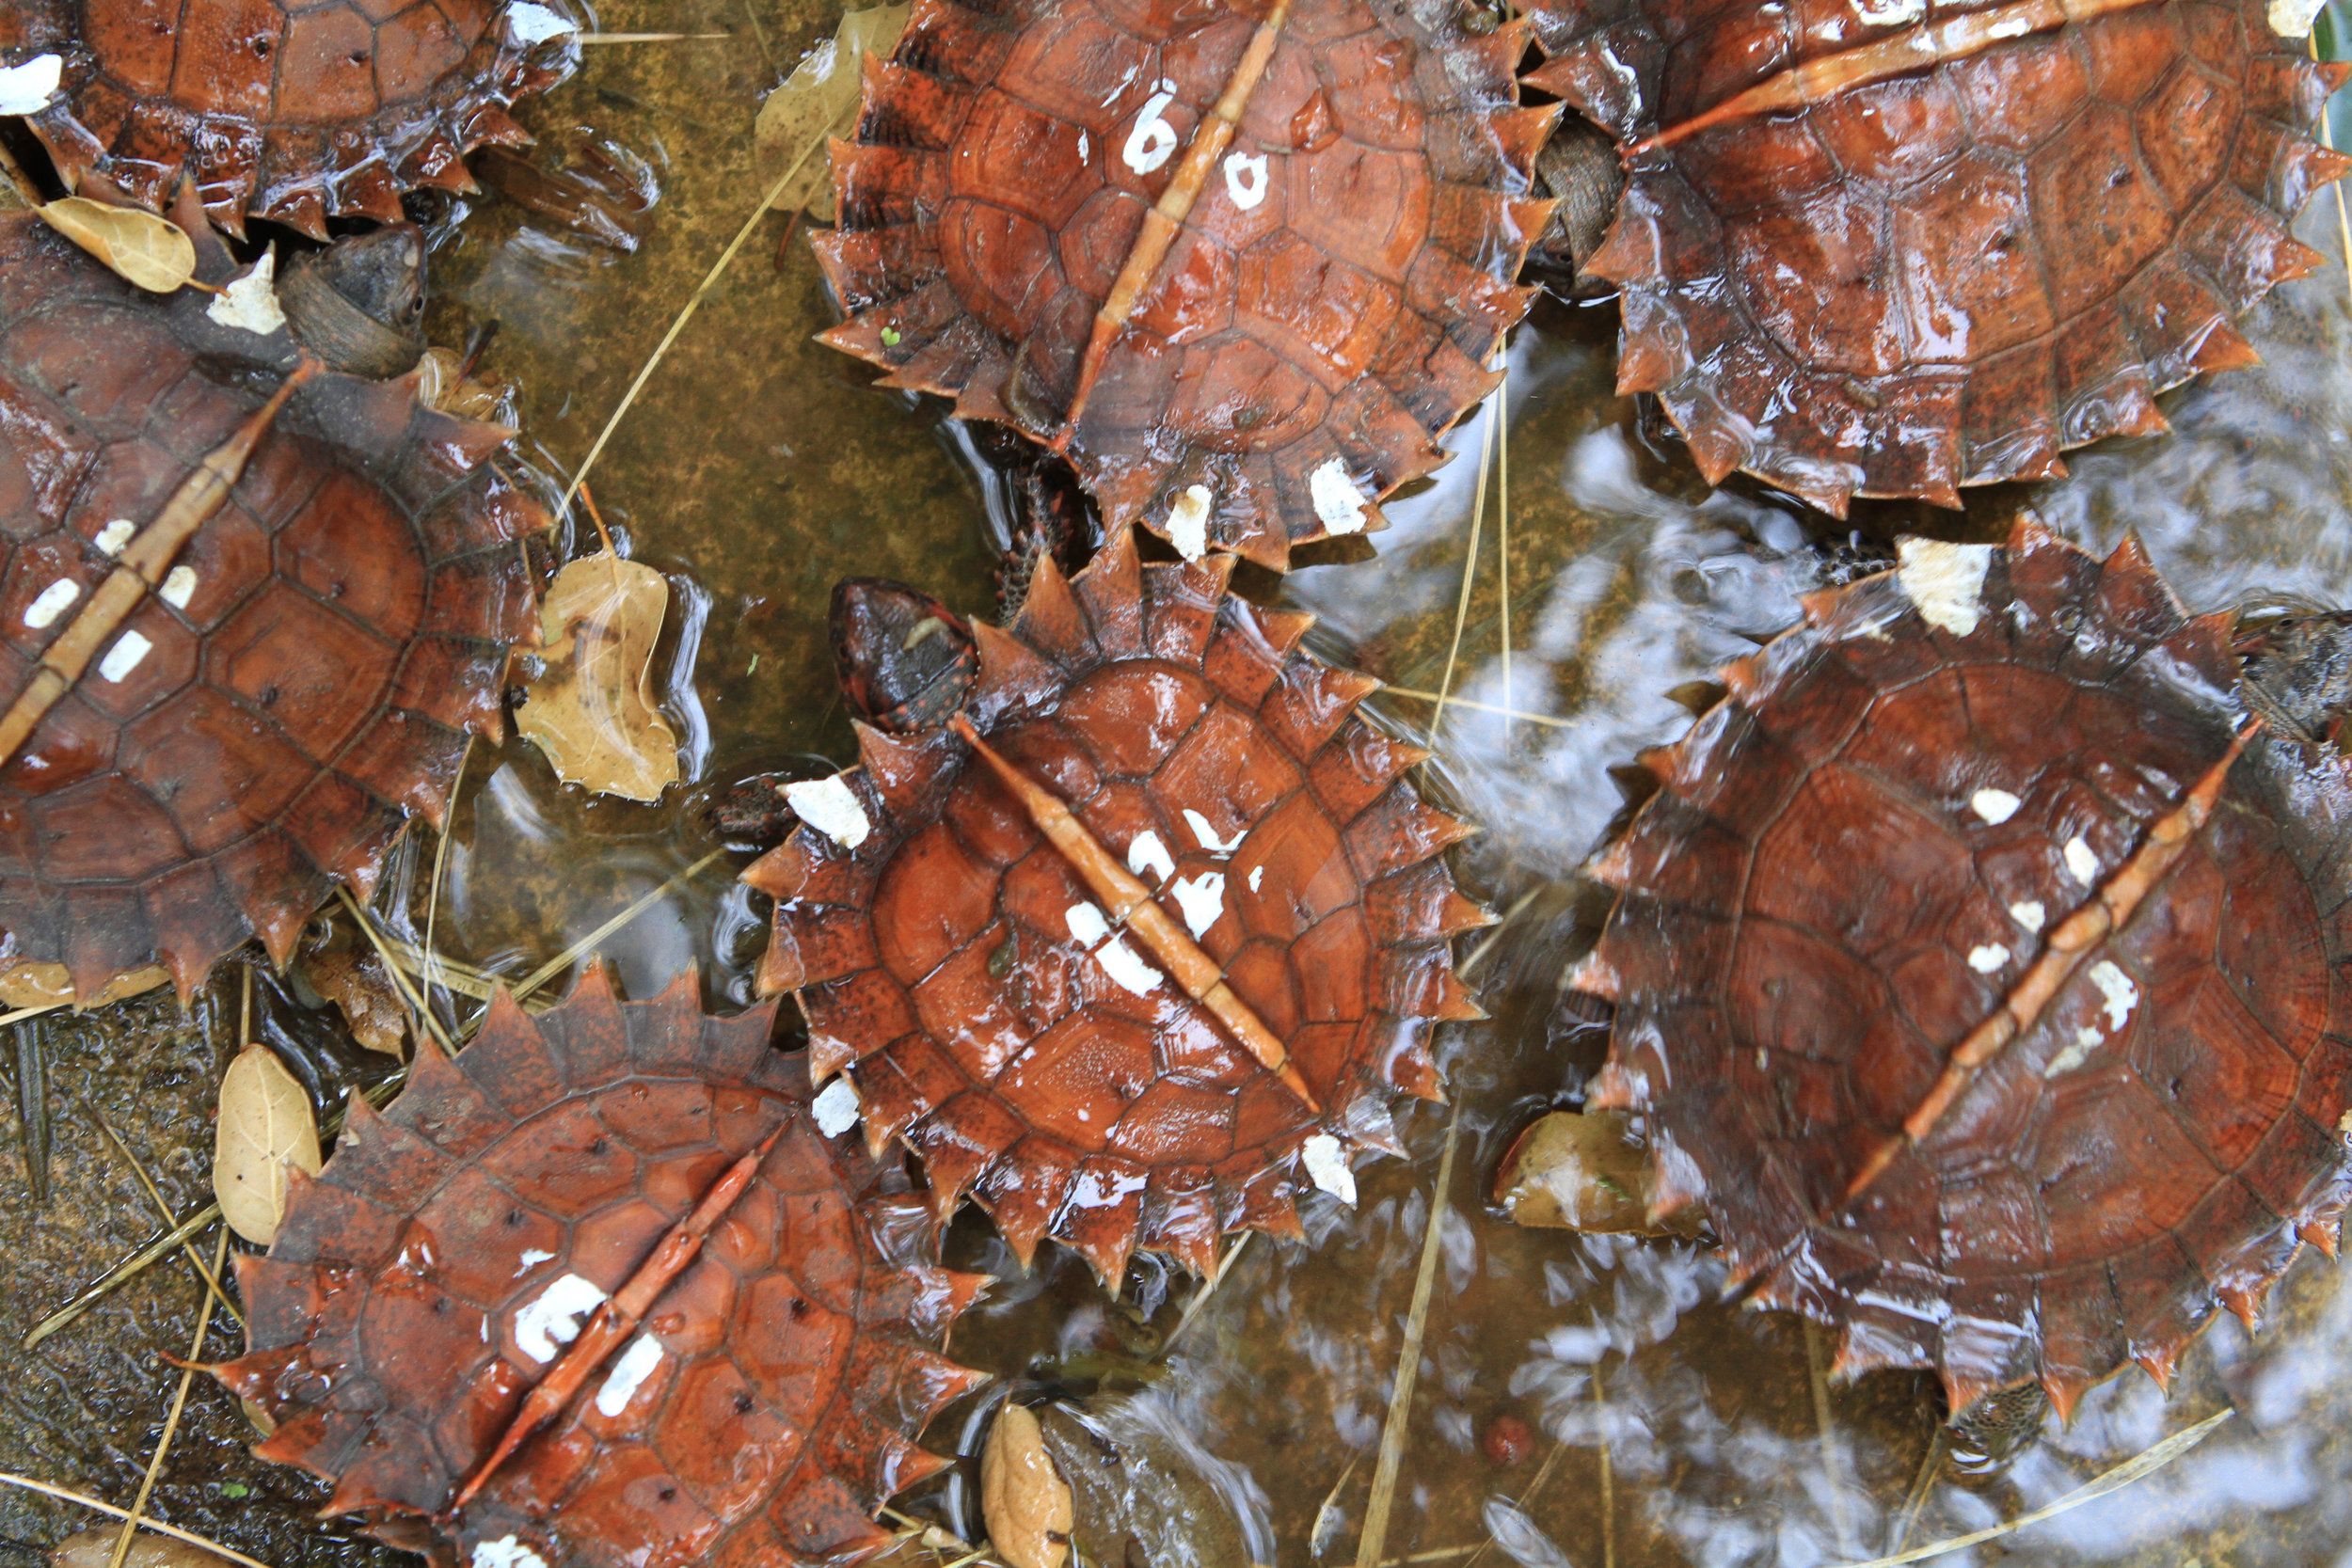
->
xmin=0 ymin=204 xmax=546 ymax=997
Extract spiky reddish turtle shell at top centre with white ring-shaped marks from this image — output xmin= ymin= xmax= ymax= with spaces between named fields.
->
xmin=814 ymin=0 xmax=1557 ymax=571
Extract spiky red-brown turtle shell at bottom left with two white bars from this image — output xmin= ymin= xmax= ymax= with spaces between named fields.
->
xmin=215 ymin=969 xmax=986 ymax=1568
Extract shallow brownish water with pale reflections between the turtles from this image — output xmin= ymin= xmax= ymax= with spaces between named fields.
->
xmin=0 ymin=0 xmax=2352 ymax=1568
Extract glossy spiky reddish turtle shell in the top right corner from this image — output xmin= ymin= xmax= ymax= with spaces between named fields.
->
xmin=1529 ymin=0 xmax=2347 ymax=515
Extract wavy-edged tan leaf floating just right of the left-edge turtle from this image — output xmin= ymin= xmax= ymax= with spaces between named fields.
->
xmin=516 ymin=550 xmax=677 ymax=800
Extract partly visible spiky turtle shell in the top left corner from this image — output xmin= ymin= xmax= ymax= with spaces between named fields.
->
xmin=0 ymin=0 xmax=579 ymax=240
